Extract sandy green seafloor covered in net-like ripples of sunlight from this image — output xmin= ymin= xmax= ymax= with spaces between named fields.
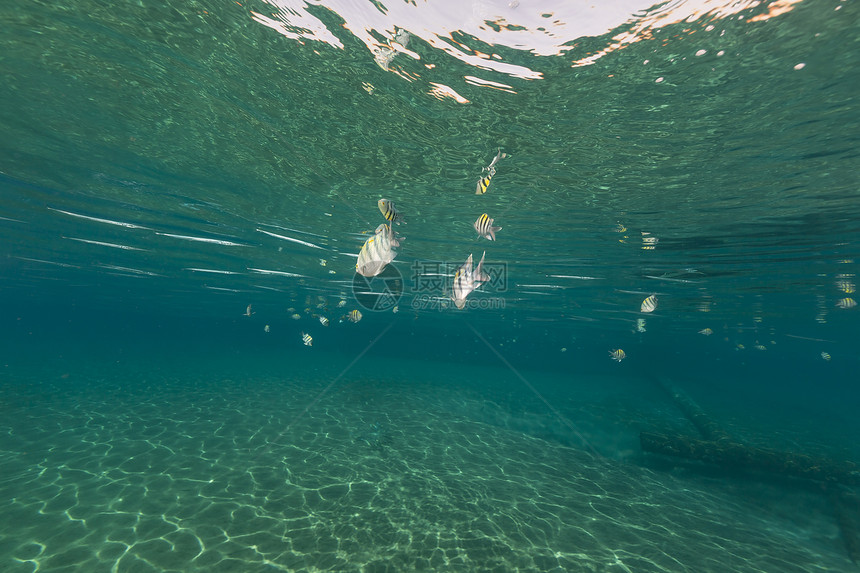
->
xmin=0 ymin=350 xmax=854 ymax=573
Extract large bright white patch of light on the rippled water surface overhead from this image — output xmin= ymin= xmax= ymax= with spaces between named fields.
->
xmin=245 ymin=0 xmax=801 ymax=81
